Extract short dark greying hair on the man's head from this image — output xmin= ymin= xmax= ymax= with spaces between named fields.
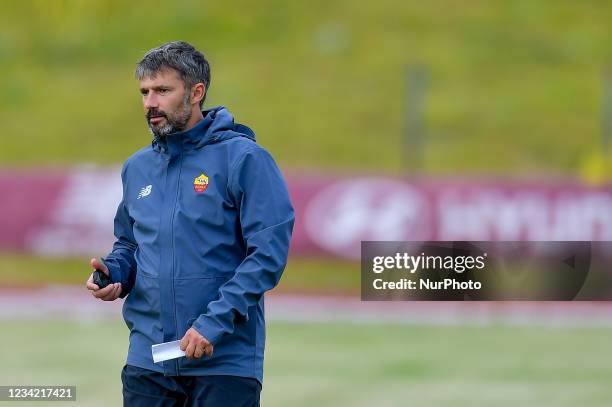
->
xmin=134 ymin=41 xmax=210 ymax=107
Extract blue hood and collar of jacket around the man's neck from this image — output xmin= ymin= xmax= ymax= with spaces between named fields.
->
xmin=152 ymin=106 xmax=255 ymax=155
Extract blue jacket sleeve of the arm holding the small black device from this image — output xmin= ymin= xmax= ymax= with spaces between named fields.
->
xmin=102 ymin=164 xmax=138 ymax=298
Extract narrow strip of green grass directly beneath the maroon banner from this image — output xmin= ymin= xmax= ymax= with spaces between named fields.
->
xmin=0 ymin=252 xmax=360 ymax=294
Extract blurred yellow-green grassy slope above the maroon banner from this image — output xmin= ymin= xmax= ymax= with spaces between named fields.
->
xmin=0 ymin=0 xmax=612 ymax=176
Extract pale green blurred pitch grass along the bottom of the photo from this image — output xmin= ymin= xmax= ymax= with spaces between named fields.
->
xmin=0 ymin=321 xmax=612 ymax=407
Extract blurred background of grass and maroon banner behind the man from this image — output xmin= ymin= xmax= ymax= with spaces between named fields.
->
xmin=0 ymin=0 xmax=612 ymax=406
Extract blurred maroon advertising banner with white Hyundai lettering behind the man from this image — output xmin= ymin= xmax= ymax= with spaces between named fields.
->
xmin=0 ymin=168 xmax=612 ymax=259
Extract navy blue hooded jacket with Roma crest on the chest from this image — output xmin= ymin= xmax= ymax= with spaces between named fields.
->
xmin=104 ymin=107 xmax=294 ymax=382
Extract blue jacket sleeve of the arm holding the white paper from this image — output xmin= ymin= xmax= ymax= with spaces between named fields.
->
xmin=192 ymin=149 xmax=295 ymax=344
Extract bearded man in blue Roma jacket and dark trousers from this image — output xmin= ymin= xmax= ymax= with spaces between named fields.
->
xmin=87 ymin=42 xmax=294 ymax=406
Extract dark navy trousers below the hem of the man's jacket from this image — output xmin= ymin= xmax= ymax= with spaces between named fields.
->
xmin=121 ymin=365 xmax=261 ymax=407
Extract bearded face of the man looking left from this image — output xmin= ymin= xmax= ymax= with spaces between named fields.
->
xmin=140 ymin=69 xmax=191 ymax=137
